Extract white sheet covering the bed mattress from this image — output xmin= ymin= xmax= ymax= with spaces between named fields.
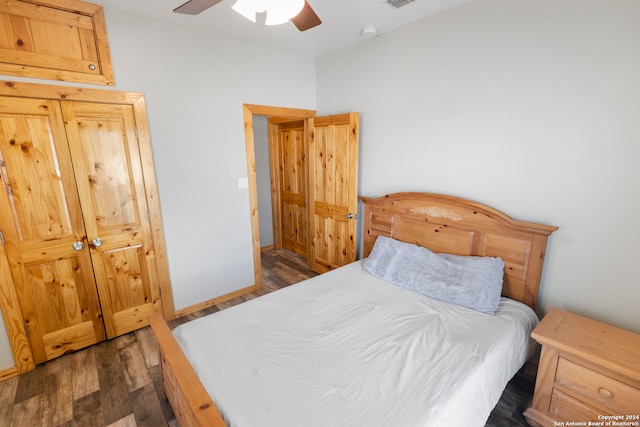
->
xmin=174 ymin=261 xmax=538 ymax=427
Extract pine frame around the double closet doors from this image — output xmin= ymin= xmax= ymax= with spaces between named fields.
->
xmin=0 ymin=80 xmax=175 ymax=373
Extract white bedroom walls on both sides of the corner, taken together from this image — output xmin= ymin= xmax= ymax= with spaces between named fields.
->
xmin=0 ymin=0 xmax=640 ymax=369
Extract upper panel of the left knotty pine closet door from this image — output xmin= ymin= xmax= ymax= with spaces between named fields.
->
xmin=0 ymin=98 xmax=77 ymax=242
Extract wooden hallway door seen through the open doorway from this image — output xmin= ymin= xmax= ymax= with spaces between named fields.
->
xmin=277 ymin=120 xmax=308 ymax=257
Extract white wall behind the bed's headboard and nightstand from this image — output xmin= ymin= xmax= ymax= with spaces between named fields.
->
xmin=316 ymin=0 xmax=640 ymax=332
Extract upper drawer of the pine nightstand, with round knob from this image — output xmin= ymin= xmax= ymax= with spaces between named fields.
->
xmin=556 ymin=357 xmax=640 ymax=414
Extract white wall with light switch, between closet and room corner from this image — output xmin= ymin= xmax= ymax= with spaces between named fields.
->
xmin=0 ymin=9 xmax=315 ymax=369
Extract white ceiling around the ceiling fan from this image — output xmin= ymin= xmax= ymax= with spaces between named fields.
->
xmin=93 ymin=0 xmax=471 ymax=57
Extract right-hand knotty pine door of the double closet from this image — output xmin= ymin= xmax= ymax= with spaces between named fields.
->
xmin=61 ymin=102 xmax=161 ymax=338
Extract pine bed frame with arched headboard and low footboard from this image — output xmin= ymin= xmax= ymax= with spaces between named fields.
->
xmin=149 ymin=193 xmax=557 ymax=427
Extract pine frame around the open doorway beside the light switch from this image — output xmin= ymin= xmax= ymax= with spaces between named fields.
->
xmin=242 ymin=104 xmax=316 ymax=289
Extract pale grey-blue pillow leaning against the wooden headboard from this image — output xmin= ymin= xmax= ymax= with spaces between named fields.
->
xmin=364 ymin=236 xmax=504 ymax=314
